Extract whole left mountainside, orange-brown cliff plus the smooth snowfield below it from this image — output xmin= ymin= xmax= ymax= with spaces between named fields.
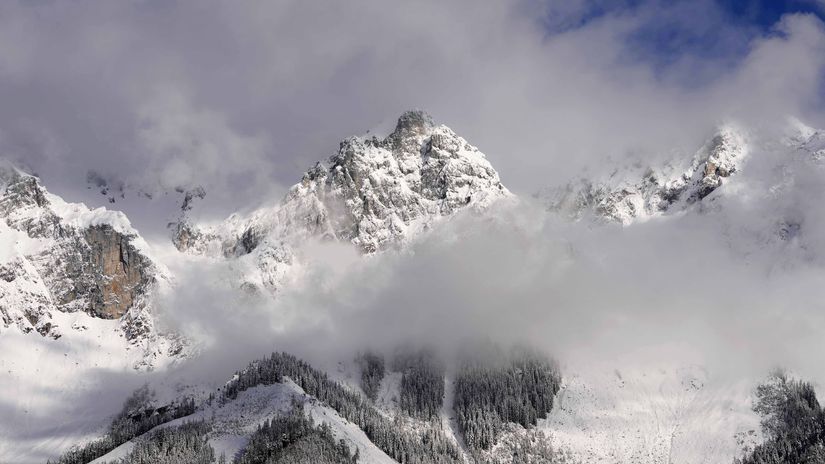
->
xmin=0 ymin=164 xmax=187 ymax=462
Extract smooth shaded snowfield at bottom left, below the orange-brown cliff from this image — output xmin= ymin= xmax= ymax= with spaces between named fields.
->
xmin=0 ymin=311 xmax=180 ymax=463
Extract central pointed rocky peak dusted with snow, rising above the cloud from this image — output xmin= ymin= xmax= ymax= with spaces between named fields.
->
xmin=172 ymin=111 xmax=511 ymax=290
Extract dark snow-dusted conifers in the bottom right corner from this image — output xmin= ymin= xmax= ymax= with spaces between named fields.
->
xmin=736 ymin=374 xmax=825 ymax=464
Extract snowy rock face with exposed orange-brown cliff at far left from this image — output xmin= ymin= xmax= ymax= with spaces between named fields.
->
xmin=0 ymin=165 xmax=156 ymax=336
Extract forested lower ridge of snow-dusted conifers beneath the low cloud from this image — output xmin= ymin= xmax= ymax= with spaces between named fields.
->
xmin=54 ymin=347 xmax=560 ymax=464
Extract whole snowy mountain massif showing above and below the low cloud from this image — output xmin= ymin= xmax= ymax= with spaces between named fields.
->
xmin=6 ymin=111 xmax=825 ymax=464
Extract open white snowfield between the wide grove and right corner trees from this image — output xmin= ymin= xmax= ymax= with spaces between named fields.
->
xmin=540 ymin=365 xmax=761 ymax=464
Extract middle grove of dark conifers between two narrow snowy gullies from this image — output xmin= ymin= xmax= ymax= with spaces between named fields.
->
xmin=393 ymin=350 xmax=444 ymax=419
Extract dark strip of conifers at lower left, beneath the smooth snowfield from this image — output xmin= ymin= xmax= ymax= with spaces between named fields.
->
xmin=50 ymin=385 xmax=195 ymax=464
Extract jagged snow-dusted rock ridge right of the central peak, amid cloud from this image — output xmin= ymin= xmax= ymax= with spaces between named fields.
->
xmin=539 ymin=126 xmax=748 ymax=224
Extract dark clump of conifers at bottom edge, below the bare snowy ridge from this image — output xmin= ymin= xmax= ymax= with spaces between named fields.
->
xmin=235 ymin=404 xmax=358 ymax=464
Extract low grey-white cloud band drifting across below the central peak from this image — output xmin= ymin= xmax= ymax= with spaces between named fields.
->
xmin=159 ymin=176 xmax=825 ymax=390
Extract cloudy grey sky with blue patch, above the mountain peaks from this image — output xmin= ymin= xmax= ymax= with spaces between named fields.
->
xmin=0 ymin=0 xmax=825 ymax=236
